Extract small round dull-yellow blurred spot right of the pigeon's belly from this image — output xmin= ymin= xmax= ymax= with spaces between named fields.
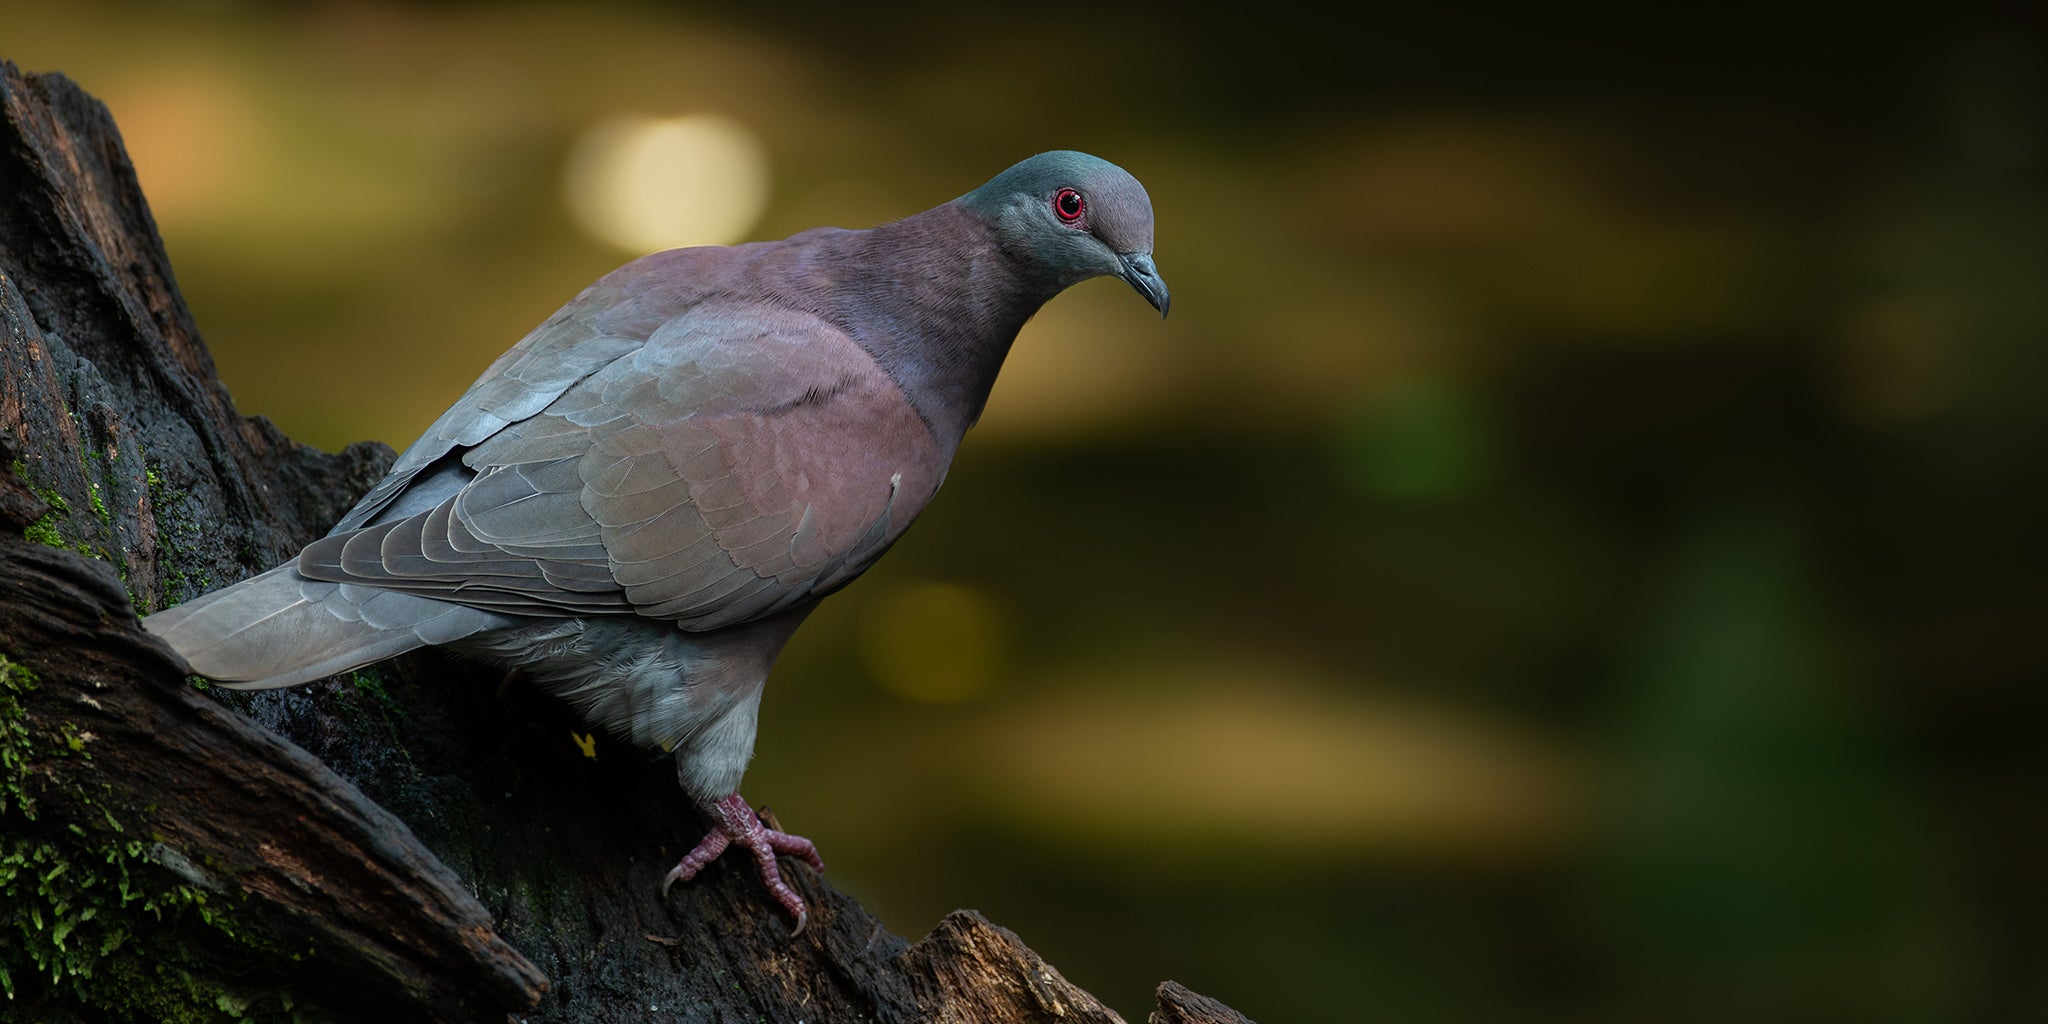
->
xmin=860 ymin=584 xmax=1004 ymax=705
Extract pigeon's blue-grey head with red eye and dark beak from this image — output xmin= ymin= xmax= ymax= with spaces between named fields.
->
xmin=961 ymin=150 xmax=1169 ymax=315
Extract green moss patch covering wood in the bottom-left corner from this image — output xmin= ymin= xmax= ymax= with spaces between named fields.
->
xmin=0 ymin=655 xmax=319 ymax=1022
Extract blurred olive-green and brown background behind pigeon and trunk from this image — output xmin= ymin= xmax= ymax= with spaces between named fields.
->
xmin=16 ymin=0 xmax=2048 ymax=1024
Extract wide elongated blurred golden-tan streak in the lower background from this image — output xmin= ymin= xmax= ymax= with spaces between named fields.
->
xmin=975 ymin=666 xmax=1589 ymax=866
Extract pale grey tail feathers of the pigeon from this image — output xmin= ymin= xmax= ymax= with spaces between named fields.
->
xmin=141 ymin=561 xmax=522 ymax=690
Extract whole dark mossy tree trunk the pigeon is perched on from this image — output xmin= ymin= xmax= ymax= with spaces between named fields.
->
xmin=0 ymin=63 xmax=1243 ymax=1024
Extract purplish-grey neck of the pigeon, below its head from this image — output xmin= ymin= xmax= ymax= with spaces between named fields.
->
xmin=817 ymin=205 xmax=1061 ymax=446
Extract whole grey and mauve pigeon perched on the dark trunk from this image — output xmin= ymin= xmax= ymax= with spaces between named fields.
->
xmin=143 ymin=152 xmax=1169 ymax=934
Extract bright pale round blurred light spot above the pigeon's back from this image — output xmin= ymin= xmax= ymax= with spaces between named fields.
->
xmin=563 ymin=115 xmax=768 ymax=254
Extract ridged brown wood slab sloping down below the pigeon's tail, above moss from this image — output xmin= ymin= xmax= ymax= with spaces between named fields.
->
xmin=0 ymin=444 xmax=545 ymax=1018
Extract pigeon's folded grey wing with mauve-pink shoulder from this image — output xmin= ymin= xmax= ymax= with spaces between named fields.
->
xmin=299 ymin=301 xmax=944 ymax=629
